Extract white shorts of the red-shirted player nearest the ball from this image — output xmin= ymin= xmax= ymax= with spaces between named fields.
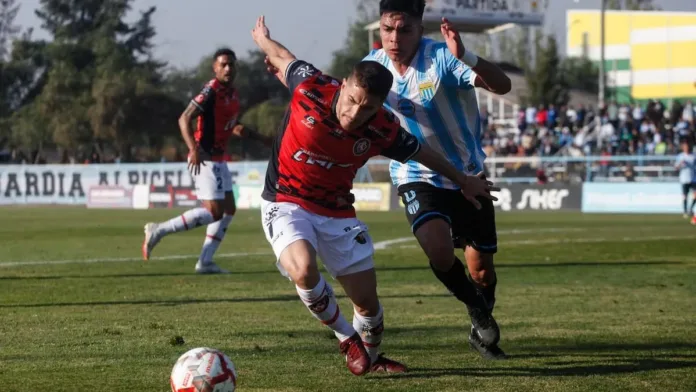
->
xmin=261 ymin=200 xmax=374 ymax=278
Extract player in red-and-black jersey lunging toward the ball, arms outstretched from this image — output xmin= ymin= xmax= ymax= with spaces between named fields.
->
xmin=252 ymin=17 xmax=497 ymax=375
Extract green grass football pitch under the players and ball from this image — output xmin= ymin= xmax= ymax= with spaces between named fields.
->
xmin=0 ymin=207 xmax=696 ymax=392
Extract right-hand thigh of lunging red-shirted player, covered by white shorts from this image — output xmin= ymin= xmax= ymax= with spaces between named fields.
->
xmin=314 ymin=217 xmax=374 ymax=278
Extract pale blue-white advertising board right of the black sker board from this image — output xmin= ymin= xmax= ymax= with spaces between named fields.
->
xmin=582 ymin=182 xmax=682 ymax=214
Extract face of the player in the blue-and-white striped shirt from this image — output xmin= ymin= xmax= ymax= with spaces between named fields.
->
xmin=379 ymin=12 xmax=423 ymax=63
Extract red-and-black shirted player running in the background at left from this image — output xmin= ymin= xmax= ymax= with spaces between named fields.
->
xmin=142 ymin=48 xmax=271 ymax=274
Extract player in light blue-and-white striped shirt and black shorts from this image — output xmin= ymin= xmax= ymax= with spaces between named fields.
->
xmin=365 ymin=0 xmax=510 ymax=359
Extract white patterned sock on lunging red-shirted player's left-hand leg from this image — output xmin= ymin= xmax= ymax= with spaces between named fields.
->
xmin=295 ymin=276 xmax=355 ymax=341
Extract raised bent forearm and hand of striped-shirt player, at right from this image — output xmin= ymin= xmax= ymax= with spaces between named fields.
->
xmin=440 ymin=18 xmax=512 ymax=95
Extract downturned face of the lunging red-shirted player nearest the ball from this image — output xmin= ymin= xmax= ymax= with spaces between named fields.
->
xmin=336 ymin=78 xmax=384 ymax=131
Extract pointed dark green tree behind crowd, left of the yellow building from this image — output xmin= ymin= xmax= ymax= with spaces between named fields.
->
xmin=525 ymin=35 xmax=569 ymax=105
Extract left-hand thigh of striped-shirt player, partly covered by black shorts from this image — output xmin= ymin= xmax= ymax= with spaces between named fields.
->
xmin=399 ymin=183 xmax=454 ymax=267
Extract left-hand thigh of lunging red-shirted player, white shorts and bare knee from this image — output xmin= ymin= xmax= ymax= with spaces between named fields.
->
xmin=261 ymin=201 xmax=319 ymax=288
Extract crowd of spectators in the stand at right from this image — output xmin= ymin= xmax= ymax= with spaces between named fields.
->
xmin=482 ymin=100 xmax=696 ymax=156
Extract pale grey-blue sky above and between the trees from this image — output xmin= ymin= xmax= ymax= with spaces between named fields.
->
xmin=16 ymin=0 xmax=696 ymax=67
